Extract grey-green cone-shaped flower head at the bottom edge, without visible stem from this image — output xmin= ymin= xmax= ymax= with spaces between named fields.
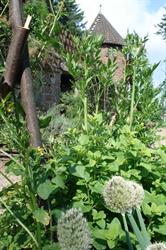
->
xmin=57 ymin=208 xmax=92 ymax=250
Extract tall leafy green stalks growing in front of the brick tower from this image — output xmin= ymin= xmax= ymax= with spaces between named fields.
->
xmin=64 ymin=34 xmax=164 ymax=145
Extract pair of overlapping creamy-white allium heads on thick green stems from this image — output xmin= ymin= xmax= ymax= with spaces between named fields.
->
xmin=103 ymin=176 xmax=144 ymax=213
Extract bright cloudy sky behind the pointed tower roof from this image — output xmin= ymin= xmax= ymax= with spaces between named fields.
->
xmin=76 ymin=0 xmax=166 ymax=85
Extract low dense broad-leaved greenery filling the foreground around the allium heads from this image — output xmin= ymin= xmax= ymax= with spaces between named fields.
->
xmin=0 ymin=114 xmax=166 ymax=249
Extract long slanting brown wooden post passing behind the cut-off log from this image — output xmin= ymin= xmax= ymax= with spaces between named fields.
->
xmin=9 ymin=0 xmax=42 ymax=147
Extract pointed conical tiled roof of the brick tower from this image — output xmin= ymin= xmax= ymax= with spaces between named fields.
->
xmin=90 ymin=13 xmax=124 ymax=46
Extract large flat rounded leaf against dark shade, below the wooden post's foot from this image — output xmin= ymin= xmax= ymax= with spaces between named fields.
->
xmin=37 ymin=180 xmax=55 ymax=200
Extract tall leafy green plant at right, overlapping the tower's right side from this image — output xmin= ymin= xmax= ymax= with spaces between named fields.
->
xmin=123 ymin=34 xmax=163 ymax=129
